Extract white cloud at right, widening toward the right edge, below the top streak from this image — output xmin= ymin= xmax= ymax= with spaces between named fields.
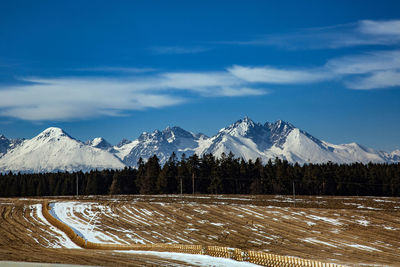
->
xmin=228 ymin=50 xmax=400 ymax=90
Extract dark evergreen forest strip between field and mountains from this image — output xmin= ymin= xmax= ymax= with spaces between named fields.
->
xmin=0 ymin=153 xmax=400 ymax=197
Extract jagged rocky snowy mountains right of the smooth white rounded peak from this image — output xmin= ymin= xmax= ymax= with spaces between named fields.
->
xmin=114 ymin=117 xmax=400 ymax=166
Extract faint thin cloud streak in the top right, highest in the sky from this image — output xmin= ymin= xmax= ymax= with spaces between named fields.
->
xmin=225 ymin=20 xmax=400 ymax=49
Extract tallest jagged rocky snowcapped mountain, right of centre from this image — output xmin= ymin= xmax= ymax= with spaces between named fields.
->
xmin=199 ymin=117 xmax=395 ymax=164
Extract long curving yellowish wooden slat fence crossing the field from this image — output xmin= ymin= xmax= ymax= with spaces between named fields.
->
xmin=42 ymin=201 xmax=343 ymax=267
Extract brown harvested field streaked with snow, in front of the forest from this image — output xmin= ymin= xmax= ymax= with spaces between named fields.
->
xmin=0 ymin=195 xmax=400 ymax=266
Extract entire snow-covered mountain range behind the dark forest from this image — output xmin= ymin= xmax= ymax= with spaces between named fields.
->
xmin=0 ymin=117 xmax=400 ymax=172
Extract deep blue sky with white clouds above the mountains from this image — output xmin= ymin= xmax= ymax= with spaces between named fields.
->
xmin=0 ymin=0 xmax=400 ymax=151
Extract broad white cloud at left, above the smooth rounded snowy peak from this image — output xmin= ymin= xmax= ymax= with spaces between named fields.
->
xmin=0 ymin=79 xmax=185 ymax=120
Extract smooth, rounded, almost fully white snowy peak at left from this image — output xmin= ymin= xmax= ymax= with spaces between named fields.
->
xmin=0 ymin=128 xmax=125 ymax=172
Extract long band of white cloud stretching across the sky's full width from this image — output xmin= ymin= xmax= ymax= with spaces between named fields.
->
xmin=0 ymin=40 xmax=400 ymax=121
